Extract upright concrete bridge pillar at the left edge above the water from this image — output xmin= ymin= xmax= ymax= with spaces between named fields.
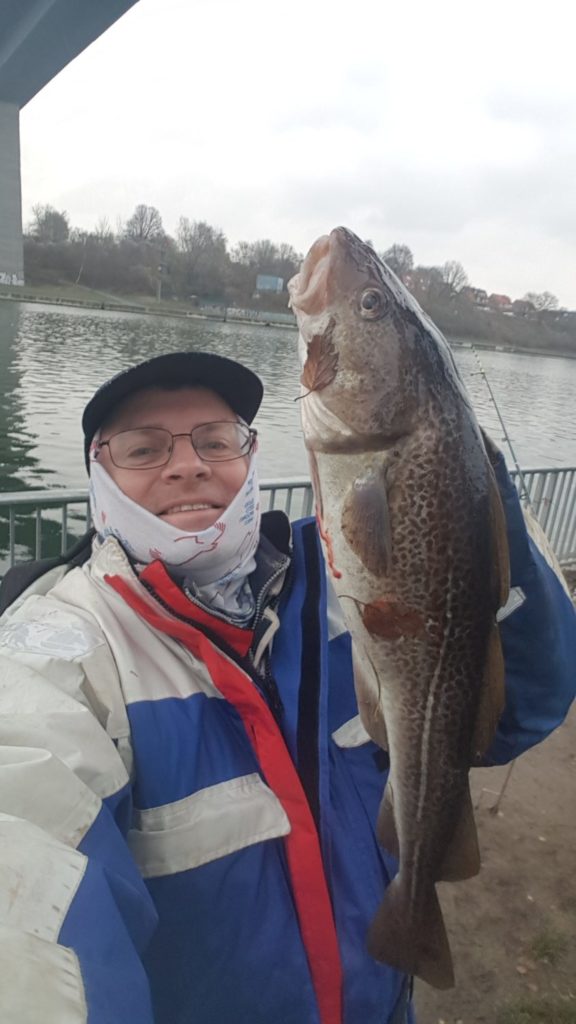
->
xmin=0 ymin=101 xmax=24 ymax=286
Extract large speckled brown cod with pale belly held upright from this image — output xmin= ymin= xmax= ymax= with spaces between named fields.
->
xmin=289 ymin=227 xmax=508 ymax=988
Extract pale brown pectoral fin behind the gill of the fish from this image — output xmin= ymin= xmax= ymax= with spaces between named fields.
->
xmin=341 ymin=469 xmax=392 ymax=577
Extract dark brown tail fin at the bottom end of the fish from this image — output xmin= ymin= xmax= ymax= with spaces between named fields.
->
xmin=368 ymin=877 xmax=454 ymax=988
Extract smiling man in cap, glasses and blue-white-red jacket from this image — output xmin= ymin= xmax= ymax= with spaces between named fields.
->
xmin=0 ymin=352 xmax=576 ymax=1024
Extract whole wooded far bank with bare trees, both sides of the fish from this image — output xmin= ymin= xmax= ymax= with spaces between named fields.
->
xmin=0 ymin=204 xmax=576 ymax=357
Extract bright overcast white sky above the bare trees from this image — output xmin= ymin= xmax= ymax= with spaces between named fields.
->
xmin=20 ymin=0 xmax=576 ymax=309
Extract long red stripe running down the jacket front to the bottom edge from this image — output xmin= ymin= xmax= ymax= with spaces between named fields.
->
xmin=105 ymin=575 xmax=342 ymax=1024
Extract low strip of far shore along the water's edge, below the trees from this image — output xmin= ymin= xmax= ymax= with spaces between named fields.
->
xmin=0 ymin=285 xmax=576 ymax=359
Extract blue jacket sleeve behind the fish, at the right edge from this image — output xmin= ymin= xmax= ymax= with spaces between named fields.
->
xmin=484 ymin=454 xmax=576 ymax=764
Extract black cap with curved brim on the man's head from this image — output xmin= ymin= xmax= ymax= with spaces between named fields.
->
xmin=82 ymin=352 xmax=263 ymax=471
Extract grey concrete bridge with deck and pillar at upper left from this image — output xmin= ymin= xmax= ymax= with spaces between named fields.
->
xmin=0 ymin=0 xmax=136 ymax=286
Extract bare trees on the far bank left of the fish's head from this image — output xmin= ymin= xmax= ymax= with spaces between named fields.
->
xmin=24 ymin=204 xmax=302 ymax=307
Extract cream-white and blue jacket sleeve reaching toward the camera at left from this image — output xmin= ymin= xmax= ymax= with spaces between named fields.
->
xmin=0 ymin=597 xmax=156 ymax=1024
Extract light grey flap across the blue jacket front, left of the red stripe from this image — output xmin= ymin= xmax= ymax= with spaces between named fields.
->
xmin=128 ymin=772 xmax=290 ymax=878
